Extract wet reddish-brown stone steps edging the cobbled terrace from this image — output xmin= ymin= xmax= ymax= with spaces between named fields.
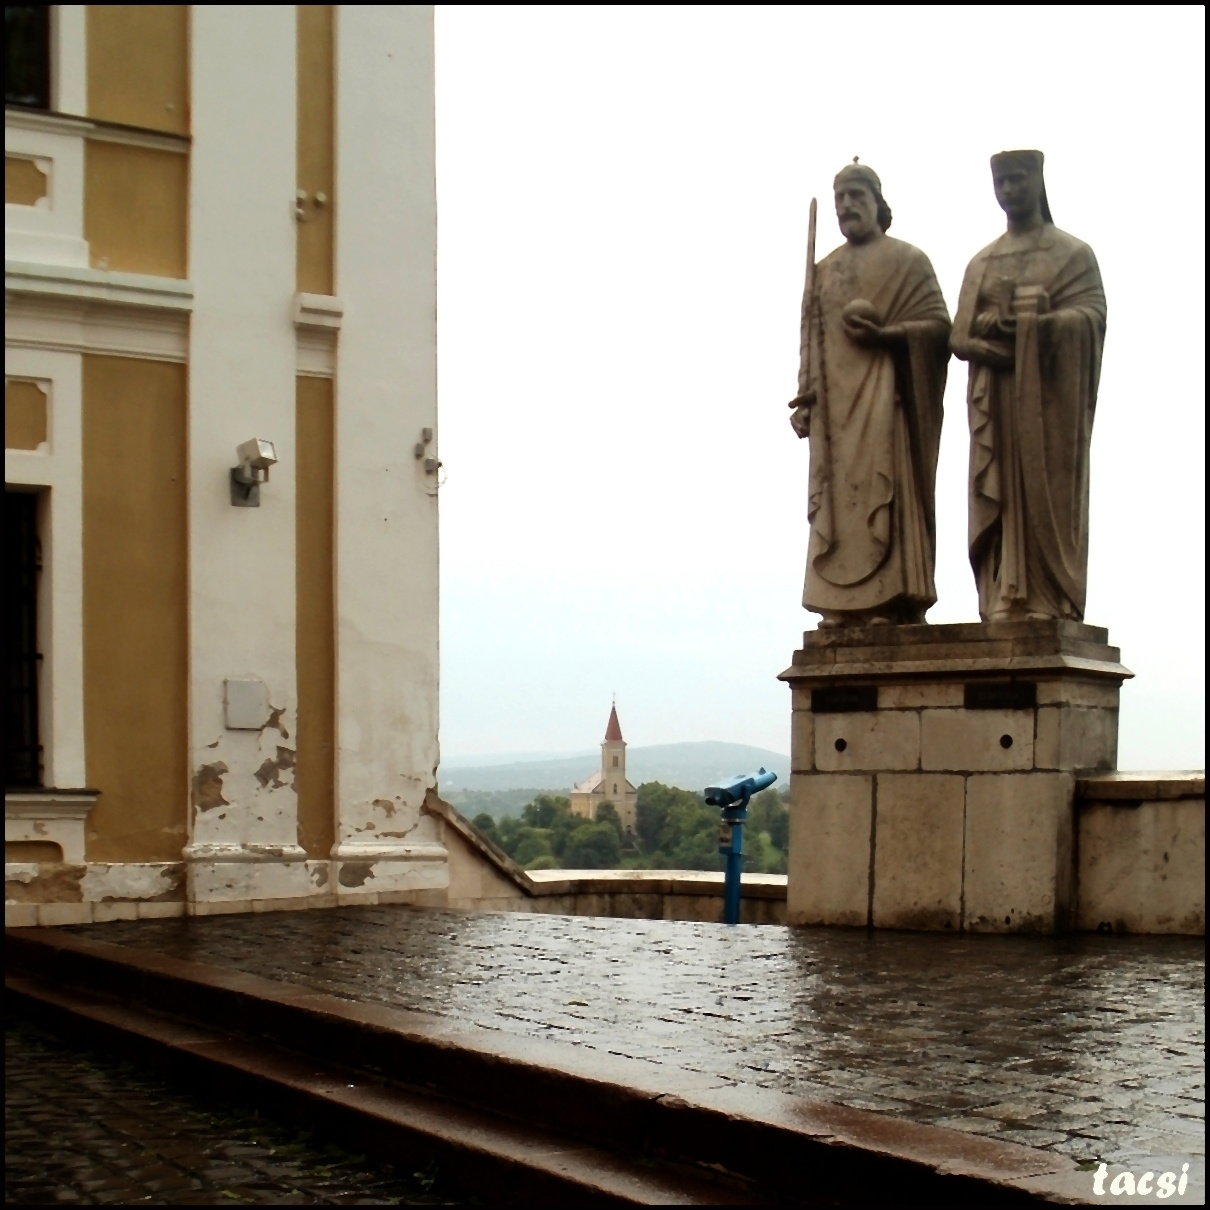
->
xmin=6 ymin=929 xmax=1093 ymax=1205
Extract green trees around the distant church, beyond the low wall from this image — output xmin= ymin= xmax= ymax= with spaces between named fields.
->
xmin=474 ymin=782 xmax=790 ymax=874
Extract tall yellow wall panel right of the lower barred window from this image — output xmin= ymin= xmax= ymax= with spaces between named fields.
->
xmin=82 ymin=355 xmax=189 ymax=862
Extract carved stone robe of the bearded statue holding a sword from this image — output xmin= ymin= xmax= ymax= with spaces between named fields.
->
xmin=800 ymin=237 xmax=950 ymax=620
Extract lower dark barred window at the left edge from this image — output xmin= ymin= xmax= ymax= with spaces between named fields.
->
xmin=4 ymin=491 xmax=42 ymax=787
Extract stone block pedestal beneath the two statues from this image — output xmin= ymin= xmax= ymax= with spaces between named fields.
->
xmin=780 ymin=621 xmax=1131 ymax=933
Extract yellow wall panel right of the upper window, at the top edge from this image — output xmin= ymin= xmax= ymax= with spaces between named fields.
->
xmin=85 ymin=4 xmax=190 ymax=134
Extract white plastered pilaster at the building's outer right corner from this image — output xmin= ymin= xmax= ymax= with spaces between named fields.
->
xmin=333 ymin=5 xmax=449 ymax=893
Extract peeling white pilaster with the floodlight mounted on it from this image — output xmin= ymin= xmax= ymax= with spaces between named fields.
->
xmin=185 ymin=5 xmax=317 ymax=901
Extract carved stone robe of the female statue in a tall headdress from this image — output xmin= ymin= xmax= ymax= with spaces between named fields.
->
xmin=953 ymin=223 xmax=1106 ymax=620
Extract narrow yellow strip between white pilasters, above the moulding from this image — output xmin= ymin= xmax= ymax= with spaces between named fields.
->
xmin=296 ymin=4 xmax=335 ymax=294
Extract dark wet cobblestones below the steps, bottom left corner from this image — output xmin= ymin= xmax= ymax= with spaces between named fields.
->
xmin=5 ymin=1025 xmax=444 ymax=1205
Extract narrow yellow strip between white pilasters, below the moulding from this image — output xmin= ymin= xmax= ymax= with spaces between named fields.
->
xmin=294 ymin=376 xmax=336 ymax=858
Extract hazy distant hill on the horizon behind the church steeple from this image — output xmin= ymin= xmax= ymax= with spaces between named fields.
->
xmin=437 ymin=741 xmax=790 ymax=806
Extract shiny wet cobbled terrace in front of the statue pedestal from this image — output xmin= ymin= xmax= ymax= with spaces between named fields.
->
xmin=63 ymin=908 xmax=1205 ymax=1182
